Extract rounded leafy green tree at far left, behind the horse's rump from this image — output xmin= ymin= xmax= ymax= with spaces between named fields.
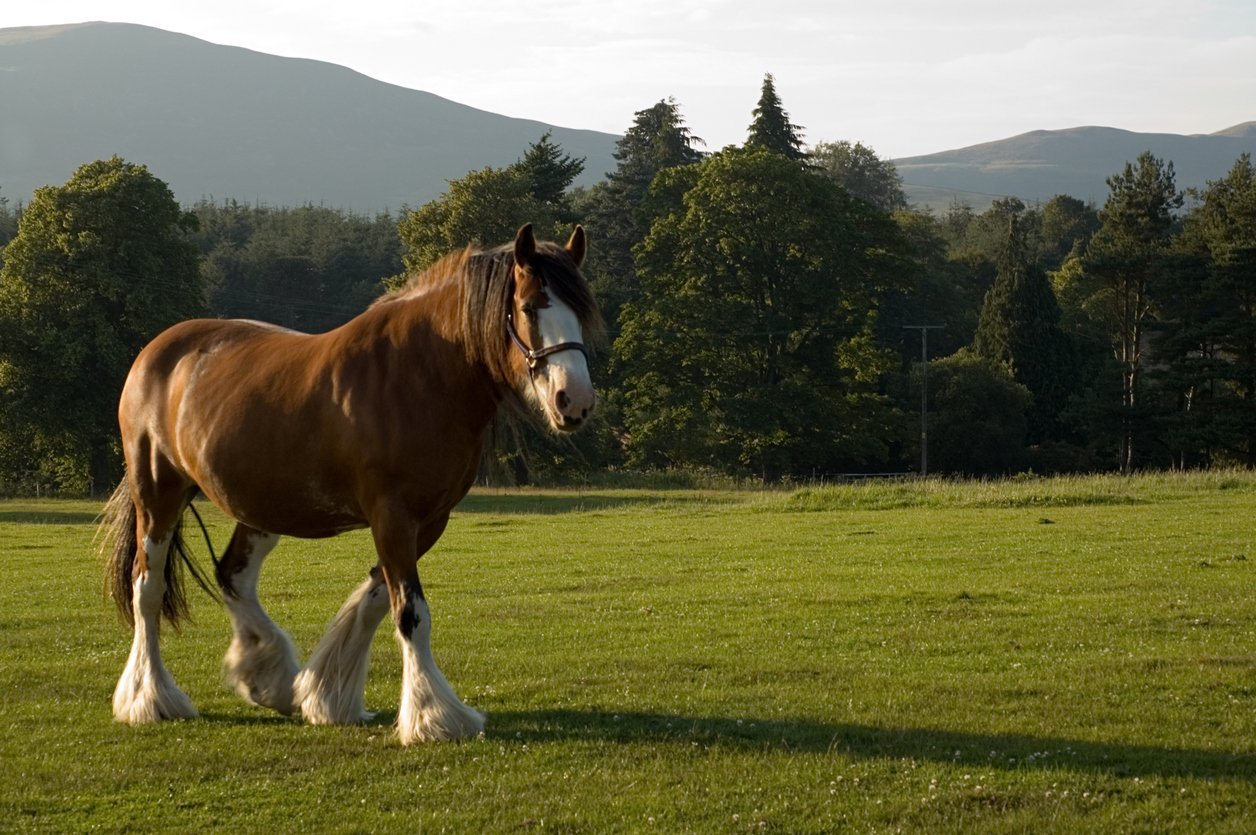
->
xmin=0 ymin=157 xmax=203 ymax=490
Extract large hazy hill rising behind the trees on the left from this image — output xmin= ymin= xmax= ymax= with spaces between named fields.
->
xmin=0 ymin=23 xmax=618 ymax=213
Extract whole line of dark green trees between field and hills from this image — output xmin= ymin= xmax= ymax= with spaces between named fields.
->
xmin=0 ymin=75 xmax=1256 ymax=491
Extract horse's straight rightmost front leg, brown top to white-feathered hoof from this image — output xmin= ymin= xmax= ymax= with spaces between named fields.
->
xmin=373 ymin=507 xmax=484 ymax=745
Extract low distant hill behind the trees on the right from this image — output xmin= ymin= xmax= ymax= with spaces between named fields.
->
xmin=894 ymin=122 xmax=1256 ymax=211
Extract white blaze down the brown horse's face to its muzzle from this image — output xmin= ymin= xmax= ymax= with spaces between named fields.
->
xmin=534 ymin=295 xmax=597 ymax=429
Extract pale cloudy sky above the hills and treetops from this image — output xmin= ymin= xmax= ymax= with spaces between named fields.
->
xmin=0 ymin=0 xmax=1256 ymax=158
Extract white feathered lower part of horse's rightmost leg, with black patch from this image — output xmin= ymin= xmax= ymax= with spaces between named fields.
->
xmin=397 ymin=594 xmax=484 ymax=745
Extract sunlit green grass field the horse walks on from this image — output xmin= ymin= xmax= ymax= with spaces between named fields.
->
xmin=0 ymin=473 xmax=1256 ymax=834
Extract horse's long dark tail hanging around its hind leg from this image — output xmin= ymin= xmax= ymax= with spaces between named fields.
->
xmin=97 ymin=478 xmax=219 ymax=629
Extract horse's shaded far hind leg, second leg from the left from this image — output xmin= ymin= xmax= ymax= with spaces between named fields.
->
xmin=217 ymin=525 xmax=300 ymax=714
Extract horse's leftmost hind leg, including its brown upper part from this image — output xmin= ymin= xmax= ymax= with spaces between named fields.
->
xmin=113 ymin=482 xmax=196 ymax=725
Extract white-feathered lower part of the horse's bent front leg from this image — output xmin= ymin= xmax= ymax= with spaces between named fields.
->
xmin=294 ymin=566 xmax=388 ymax=725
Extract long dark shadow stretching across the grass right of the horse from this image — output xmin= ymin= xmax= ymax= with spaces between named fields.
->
xmin=485 ymin=709 xmax=1256 ymax=782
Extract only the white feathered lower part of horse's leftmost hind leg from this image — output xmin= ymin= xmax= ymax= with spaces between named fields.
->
xmin=113 ymin=536 xmax=196 ymax=725
